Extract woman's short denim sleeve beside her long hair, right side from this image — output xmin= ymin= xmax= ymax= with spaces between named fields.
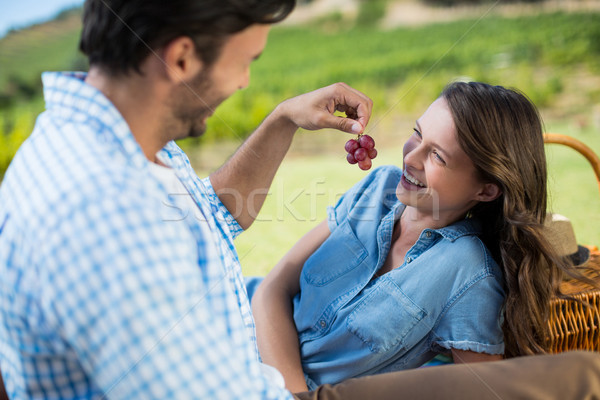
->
xmin=433 ymin=275 xmax=504 ymax=354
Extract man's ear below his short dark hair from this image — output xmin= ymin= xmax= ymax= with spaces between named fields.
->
xmin=162 ymin=36 xmax=204 ymax=83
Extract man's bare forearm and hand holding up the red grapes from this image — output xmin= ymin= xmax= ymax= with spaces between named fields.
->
xmin=210 ymin=83 xmax=373 ymax=229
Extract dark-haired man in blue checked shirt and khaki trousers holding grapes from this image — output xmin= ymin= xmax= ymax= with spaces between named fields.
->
xmin=0 ymin=0 xmax=600 ymax=399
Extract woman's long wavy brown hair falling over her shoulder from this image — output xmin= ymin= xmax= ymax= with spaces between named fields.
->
xmin=442 ymin=82 xmax=569 ymax=357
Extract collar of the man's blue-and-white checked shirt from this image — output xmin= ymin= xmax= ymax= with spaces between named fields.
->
xmin=42 ymin=72 xmax=149 ymax=168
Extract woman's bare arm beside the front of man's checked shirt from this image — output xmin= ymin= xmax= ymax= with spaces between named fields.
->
xmin=252 ymin=221 xmax=329 ymax=392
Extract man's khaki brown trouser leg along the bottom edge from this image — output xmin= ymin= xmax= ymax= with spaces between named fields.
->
xmin=294 ymin=351 xmax=600 ymax=400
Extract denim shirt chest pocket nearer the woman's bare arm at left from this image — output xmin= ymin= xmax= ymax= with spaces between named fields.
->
xmin=302 ymin=221 xmax=368 ymax=286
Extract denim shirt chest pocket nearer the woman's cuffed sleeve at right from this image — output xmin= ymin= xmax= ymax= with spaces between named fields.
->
xmin=346 ymin=277 xmax=427 ymax=353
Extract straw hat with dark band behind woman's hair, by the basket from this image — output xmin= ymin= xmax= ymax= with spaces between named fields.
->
xmin=544 ymin=213 xmax=590 ymax=267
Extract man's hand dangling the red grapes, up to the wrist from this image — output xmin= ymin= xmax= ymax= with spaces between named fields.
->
xmin=276 ymin=83 xmax=373 ymax=134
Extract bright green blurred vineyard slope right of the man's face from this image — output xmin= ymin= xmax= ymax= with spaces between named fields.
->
xmin=179 ymin=13 xmax=600 ymax=145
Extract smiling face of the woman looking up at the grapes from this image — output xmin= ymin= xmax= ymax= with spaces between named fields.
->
xmin=396 ymin=98 xmax=486 ymax=224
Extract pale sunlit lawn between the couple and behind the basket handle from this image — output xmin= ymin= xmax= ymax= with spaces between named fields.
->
xmin=191 ymin=117 xmax=600 ymax=275
